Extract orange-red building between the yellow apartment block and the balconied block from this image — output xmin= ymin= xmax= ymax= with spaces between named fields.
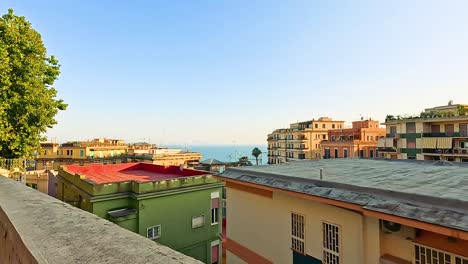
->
xmin=321 ymin=119 xmax=385 ymax=159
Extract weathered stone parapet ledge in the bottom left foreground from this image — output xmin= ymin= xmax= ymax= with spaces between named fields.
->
xmin=0 ymin=177 xmax=202 ymax=264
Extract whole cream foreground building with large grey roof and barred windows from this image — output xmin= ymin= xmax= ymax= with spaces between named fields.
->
xmin=219 ymin=159 xmax=468 ymax=264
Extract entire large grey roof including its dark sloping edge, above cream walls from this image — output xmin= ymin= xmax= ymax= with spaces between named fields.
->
xmin=221 ymin=159 xmax=468 ymax=231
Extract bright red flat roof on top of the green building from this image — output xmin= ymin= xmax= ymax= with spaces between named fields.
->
xmin=64 ymin=163 xmax=207 ymax=184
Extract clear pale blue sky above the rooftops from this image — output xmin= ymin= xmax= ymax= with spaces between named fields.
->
xmin=0 ymin=0 xmax=468 ymax=145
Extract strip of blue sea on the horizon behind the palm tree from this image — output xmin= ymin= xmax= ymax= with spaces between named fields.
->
xmin=167 ymin=145 xmax=268 ymax=165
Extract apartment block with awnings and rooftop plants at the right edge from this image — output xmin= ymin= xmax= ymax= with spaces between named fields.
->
xmin=378 ymin=102 xmax=468 ymax=162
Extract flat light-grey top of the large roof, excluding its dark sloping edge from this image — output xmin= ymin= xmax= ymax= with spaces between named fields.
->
xmin=229 ymin=159 xmax=468 ymax=201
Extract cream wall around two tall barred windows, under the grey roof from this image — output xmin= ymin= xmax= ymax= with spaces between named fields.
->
xmin=227 ymin=188 xmax=372 ymax=264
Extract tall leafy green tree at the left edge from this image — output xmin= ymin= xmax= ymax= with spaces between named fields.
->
xmin=0 ymin=9 xmax=67 ymax=158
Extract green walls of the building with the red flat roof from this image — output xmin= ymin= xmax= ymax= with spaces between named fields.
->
xmin=57 ymin=164 xmax=224 ymax=264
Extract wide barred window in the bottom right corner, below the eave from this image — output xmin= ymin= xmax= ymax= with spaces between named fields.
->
xmin=414 ymin=244 xmax=468 ymax=264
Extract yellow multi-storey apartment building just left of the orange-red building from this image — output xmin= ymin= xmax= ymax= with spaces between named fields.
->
xmin=267 ymin=117 xmax=344 ymax=164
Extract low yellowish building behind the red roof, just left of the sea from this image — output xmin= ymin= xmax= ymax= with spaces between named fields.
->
xmin=126 ymin=143 xmax=202 ymax=168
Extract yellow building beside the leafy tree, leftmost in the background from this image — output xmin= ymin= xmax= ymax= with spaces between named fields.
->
xmin=36 ymin=138 xmax=128 ymax=170
